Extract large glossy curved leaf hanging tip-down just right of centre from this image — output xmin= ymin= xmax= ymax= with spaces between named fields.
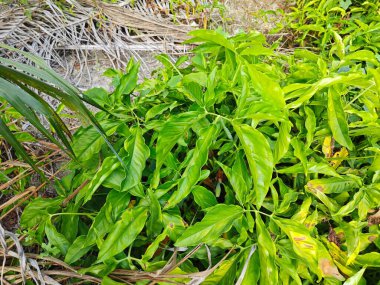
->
xmin=234 ymin=124 xmax=274 ymax=208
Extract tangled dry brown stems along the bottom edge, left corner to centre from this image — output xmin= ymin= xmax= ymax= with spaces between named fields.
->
xmin=0 ymin=223 xmax=231 ymax=285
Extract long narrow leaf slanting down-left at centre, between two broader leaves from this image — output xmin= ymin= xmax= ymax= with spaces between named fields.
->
xmin=165 ymin=124 xmax=219 ymax=208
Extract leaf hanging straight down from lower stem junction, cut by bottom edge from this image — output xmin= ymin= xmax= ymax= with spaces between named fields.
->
xmin=256 ymin=212 xmax=278 ymax=285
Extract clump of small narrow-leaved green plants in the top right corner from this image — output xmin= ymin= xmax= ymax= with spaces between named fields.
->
xmin=285 ymin=0 xmax=380 ymax=53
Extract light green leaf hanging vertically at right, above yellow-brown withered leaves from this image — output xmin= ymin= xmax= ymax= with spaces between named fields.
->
xmin=327 ymin=87 xmax=354 ymax=150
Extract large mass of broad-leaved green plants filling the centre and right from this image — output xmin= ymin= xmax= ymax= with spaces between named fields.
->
xmin=21 ymin=30 xmax=380 ymax=284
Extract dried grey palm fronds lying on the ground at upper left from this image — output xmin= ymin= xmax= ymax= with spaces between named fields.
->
xmin=0 ymin=0 xmax=220 ymax=88
